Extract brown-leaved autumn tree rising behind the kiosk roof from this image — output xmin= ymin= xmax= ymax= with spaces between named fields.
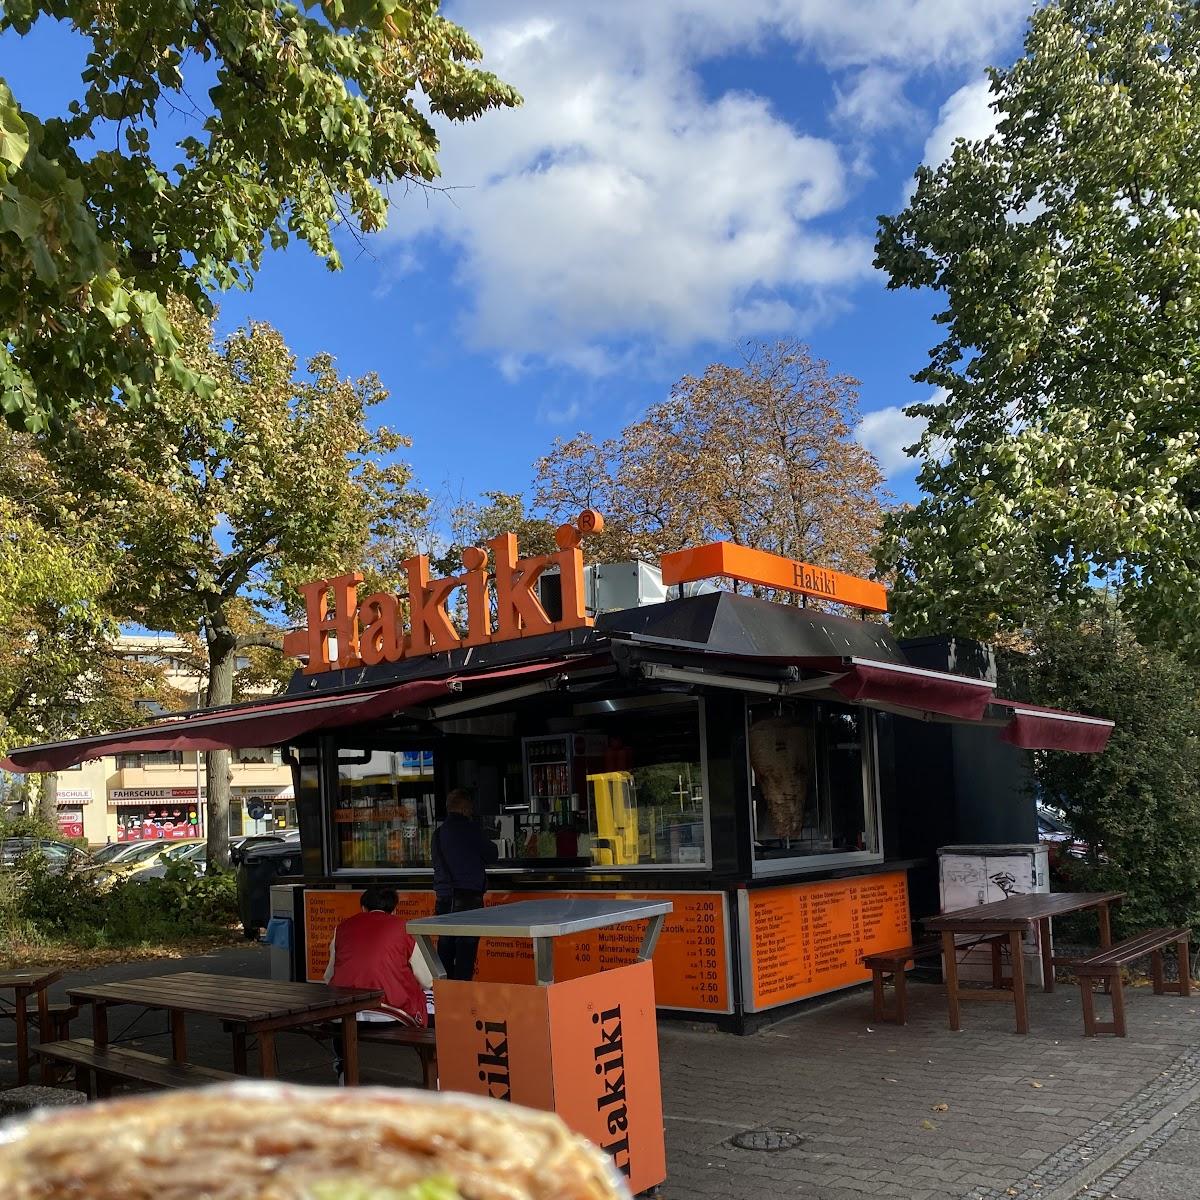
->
xmin=534 ymin=342 xmax=886 ymax=588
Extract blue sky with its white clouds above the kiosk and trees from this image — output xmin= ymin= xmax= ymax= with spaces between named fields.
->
xmin=0 ymin=0 xmax=1030 ymax=499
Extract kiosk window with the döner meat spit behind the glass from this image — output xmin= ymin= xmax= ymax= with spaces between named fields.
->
xmin=750 ymin=701 xmax=878 ymax=862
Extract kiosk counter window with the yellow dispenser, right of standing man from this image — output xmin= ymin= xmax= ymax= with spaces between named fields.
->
xmin=499 ymin=702 xmax=706 ymax=866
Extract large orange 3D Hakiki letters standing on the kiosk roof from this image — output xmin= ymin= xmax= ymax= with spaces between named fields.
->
xmin=283 ymin=509 xmax=604 ymax=674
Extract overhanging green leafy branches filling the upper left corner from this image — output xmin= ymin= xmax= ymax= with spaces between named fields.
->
xmin=0 ymin=0 xmax=520 ymax=431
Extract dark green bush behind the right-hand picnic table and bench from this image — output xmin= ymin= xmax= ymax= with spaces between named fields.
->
xmin=1001 ymin=601 xmax=1200 ymax=932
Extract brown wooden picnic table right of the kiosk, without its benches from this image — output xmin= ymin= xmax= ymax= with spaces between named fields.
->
xmin=924 ymin=892 xmax=1124 ymax=1033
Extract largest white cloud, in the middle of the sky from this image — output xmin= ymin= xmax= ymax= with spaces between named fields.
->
xmin=379 ymin=0 xmax=1025 ymax=373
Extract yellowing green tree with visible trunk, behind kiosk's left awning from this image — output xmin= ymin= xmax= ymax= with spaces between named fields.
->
xmin=46 ymin=304 xmax=425 ymax=866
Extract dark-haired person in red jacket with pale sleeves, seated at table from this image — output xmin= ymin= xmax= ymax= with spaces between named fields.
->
xmin=325 ymin=884 xmax=433 ymax=1082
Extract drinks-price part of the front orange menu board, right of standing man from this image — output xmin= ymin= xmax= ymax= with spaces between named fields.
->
xmin=475 ymin=892 xmax=732 ymax=1013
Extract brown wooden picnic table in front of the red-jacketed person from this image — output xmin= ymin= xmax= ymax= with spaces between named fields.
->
xmin=68 ymin=971 xmax=383 ymax=1085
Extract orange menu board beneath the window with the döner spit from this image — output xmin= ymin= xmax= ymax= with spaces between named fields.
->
xmin=742 ymin=871 xmax=912 ymax=1012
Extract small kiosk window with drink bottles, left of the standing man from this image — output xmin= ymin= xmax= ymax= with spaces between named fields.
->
xmin=332 ymin=746 xmax=434 ymax=870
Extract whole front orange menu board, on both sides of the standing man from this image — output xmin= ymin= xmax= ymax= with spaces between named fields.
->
xmin=304 ymin=889 xmax=732 ymax=1013
